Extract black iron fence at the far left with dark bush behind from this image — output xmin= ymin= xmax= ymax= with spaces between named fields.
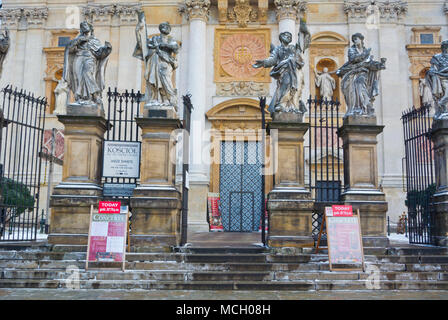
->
xmin=0 ymin=86 xmax=47 ymax=241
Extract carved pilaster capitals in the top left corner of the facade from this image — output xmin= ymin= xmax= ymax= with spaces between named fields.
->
xmin=0 ymin=7 xmax=48 ymax=29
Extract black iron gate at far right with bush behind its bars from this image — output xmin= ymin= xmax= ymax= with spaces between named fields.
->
xmin=401 ymin=105 xmax=436 ymax=244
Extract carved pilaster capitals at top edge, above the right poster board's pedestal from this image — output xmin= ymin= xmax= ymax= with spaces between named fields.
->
xmin=344 ymin=0 xmax=408 ymax=22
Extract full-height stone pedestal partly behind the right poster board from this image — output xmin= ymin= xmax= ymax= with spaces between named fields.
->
xmin=338 ymin=116 xmax=389 ymax=247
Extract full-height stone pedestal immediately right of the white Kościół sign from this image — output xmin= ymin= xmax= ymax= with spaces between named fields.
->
xmin=131 ymin=118 xmax=182 ymax=252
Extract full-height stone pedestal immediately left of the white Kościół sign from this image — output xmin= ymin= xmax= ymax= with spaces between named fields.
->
xmin=48 ymin=114 xmax=107 ymax=245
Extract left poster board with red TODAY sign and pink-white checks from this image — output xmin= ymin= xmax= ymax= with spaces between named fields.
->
xmin=86 ymin=201 xmax=129 ymax=271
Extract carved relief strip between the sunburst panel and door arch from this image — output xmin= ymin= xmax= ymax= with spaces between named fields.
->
xmin=216 ymin=81 xmax=269 ymax=97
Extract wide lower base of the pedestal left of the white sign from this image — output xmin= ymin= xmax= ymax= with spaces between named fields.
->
xmin=48 ymin=183 xmax=102 ymax=245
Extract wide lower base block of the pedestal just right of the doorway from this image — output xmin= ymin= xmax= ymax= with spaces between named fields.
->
xmin=267 ymin=188 xmax=314 ymax=248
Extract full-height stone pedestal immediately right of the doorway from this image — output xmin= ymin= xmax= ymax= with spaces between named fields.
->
xmin=267 ymin=119 xmax=314 ymax=247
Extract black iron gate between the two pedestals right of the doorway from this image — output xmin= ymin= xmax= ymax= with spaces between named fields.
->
xmin=305 ymin=97 xmax=344 ymax=240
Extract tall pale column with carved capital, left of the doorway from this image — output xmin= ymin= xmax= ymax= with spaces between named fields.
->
xmin=185 ymin=0 xmax=210 ymax=232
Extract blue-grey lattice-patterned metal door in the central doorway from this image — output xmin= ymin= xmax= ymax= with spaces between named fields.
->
xmin=219 ymin=141 xmax=264 ymax=232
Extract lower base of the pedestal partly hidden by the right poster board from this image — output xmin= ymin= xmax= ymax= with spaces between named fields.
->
xmin=342 ymin=190 xmax=389 ymax=247
